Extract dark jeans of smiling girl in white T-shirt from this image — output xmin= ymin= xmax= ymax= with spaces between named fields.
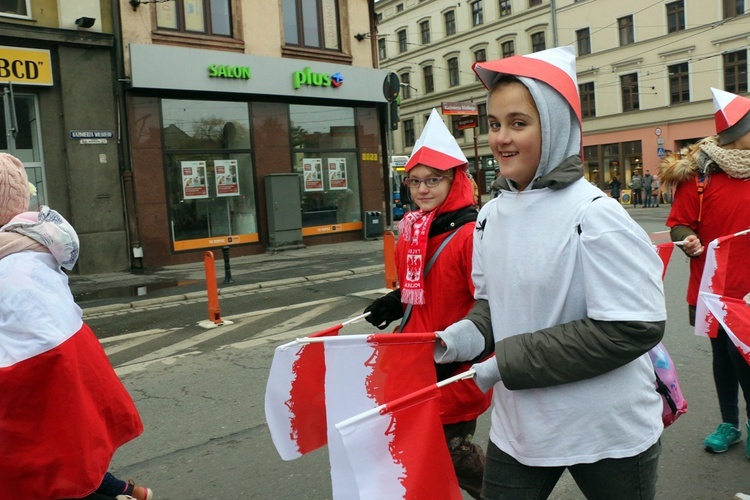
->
xmin=482 ymin=441 xmax=661 ymax=500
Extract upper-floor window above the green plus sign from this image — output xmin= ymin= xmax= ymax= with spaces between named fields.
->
xmin=282 ymin=0 xmax=341 ymax=50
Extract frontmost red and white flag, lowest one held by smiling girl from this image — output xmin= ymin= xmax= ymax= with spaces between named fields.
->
xmin=336 ymin=385 xmax=463 ymax=500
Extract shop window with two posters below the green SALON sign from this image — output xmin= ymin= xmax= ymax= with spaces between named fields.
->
xmin=161 ymin=99 xmax=258 ymax=251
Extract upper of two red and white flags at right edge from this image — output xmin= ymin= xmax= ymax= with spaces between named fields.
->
xmin=695 ymin=229 xmax=750 ymax=338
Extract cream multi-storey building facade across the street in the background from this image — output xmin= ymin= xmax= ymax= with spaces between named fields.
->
xmin=375 ymin=0 xmax=748 ymax=189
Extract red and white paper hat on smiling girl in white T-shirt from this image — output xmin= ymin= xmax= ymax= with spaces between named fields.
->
xmin=472 ymin=46 xmax=583 ymax=123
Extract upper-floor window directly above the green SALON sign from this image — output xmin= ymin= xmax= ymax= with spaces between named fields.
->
xmin=154 ymin=0 xmax=232 ymax=36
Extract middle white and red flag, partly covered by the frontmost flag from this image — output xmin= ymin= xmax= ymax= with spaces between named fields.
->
xmin=320 ymin=332 xmax=445 ymax=500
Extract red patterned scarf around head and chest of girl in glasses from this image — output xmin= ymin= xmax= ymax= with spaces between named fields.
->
xmin=398 ymin=167 xmax=474 ymax=305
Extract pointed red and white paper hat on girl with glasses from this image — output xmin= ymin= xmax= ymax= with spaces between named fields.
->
xmin=404 ymin=108 xmax=469 ymax=172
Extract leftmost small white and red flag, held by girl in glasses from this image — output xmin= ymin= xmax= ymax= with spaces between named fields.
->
xmin=265 ymin=324 xmax=344 ymax=460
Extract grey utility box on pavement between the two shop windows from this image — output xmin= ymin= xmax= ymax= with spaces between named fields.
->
xmin=265 ymin=174 xmax=302 ymax=247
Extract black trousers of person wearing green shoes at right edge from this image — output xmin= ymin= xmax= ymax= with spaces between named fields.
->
xmin=711 ymin=328 xmax=750 ymax=427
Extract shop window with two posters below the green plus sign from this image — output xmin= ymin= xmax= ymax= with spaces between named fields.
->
xmin=289 ymin=105 xmax=362 ymax=236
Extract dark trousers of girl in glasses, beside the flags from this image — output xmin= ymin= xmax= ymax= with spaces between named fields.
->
xmin=443 ymin=420 xmax=485 ymax=499
